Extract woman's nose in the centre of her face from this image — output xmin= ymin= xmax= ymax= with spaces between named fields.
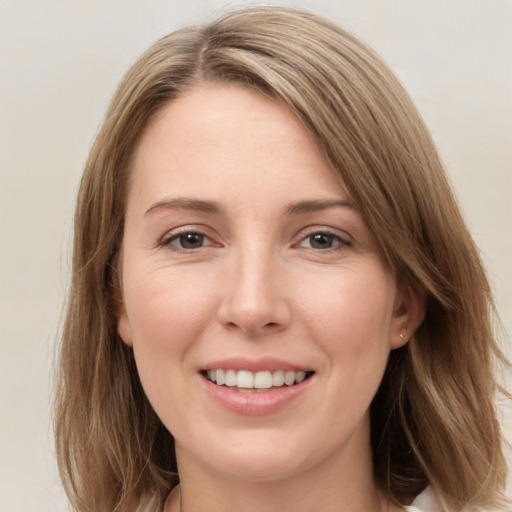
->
xmin=218 ymin=250 xmax=291 ymax=337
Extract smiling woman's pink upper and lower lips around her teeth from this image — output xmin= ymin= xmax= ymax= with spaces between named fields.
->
xmin=198 ymin=358 xmax=315 ymax=416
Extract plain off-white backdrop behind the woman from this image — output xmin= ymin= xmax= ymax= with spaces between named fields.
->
xmin=0 ymin=0 xmax=512 ymax=512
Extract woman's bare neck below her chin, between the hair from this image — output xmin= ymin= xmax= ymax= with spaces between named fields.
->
xmin=166 ymin=424 xmax=397 ymax=512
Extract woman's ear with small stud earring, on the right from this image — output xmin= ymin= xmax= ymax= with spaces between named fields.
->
xmin=389 ymin=283 xmax=426 ymax=350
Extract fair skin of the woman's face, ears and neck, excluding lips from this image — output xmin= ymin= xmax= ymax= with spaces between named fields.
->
xmin=118 ymin=85 xmax=423 ymax=512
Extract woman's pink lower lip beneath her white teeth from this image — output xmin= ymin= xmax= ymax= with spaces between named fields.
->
xmin=200 ymin=376 xmax=313 ymax=416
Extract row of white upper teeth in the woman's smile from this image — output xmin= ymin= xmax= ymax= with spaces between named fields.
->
xmin=206 ymin=369 xmax=310 ymax=392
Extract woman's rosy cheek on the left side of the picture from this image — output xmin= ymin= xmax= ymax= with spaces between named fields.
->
xmin=125 ymin=272 xmax=213 ymax=404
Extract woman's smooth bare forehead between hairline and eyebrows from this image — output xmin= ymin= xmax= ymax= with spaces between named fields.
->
xmin=131 ymin=84 xmax=343 ymax=209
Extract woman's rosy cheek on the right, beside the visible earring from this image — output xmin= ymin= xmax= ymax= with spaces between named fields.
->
xmin=302 ymin=269 xmax=396 ymax=386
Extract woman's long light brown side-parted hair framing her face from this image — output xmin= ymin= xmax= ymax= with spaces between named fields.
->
xmin=55 ymin=7 xmax=505 ymax=512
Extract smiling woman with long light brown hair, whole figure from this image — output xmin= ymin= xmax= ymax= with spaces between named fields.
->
xmin=56 ymin=7 xmax=505 ymax=512
